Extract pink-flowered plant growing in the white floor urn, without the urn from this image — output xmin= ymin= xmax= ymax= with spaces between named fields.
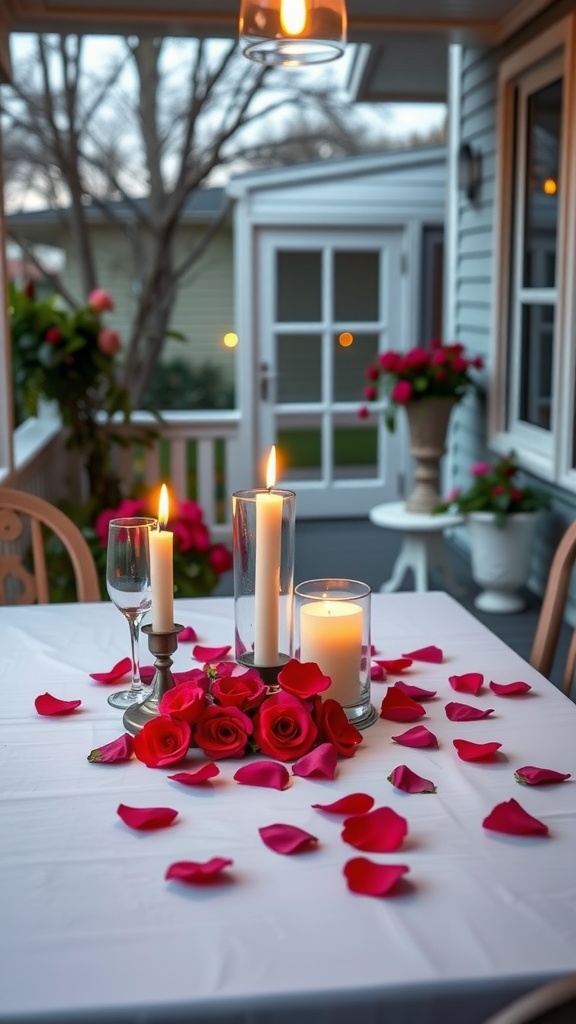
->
xmin=435 ymin=452 xmax=549 ymax=526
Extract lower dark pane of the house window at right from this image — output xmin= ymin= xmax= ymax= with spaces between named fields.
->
xmin=520 ymin=305 xmax=554 ymax=430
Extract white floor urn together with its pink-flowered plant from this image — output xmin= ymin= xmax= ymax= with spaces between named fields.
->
xmin=435 ymin=453 xmax=549 ymax=613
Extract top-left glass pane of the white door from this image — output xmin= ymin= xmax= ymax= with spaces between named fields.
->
xmin=276 ymin=250 xmax=322 ymax=324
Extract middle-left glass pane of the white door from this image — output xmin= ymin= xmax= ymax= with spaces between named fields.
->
xmin=276 ymin=334 xmax=322 ymax=402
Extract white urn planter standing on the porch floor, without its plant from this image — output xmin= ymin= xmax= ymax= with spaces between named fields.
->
xmin=466 ymin=512 xmax=538 ymax=614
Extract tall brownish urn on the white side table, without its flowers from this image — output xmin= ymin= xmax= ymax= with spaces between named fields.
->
xmin=404 ymin=397 xmax=457 ymax=512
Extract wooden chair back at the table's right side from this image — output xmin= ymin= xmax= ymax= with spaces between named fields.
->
xmin=530 ymin=520 xmax=576 ymax=693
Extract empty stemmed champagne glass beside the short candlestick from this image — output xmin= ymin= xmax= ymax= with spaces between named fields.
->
xmin=106 ymin=516 xmax=158 ymax=708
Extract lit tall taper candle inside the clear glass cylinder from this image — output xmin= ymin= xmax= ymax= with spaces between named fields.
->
xmin=254 ymin=445 xmax=282 ymax=667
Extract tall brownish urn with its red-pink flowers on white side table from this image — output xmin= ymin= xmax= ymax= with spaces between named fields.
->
xmin=359 ymin=339 xmax=484 ymax=512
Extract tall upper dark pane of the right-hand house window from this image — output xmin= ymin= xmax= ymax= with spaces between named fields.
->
xmin=524 ymin=80 xmax=562 ymax=288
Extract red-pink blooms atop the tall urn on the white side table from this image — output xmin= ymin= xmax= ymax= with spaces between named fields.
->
xmin=359 ymin=339 xmax=484 ymax=432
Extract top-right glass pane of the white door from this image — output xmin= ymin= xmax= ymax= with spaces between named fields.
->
xmin=334 ymin=250 xmax=380 ymax=322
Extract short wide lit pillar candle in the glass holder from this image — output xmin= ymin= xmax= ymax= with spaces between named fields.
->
xmin=300 ymin=599 xmax=363 ymax=707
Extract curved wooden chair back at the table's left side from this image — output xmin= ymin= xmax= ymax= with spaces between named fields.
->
xmin=0 ymin=487 xmax=100 ymax=605
